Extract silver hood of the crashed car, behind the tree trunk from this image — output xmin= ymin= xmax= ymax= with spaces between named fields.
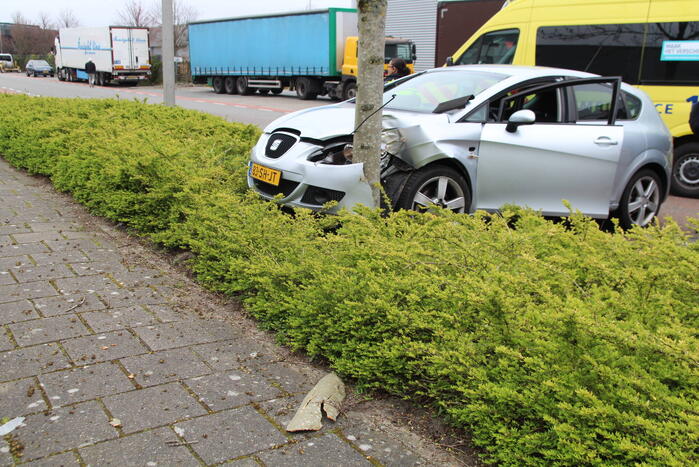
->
xmin=264 ymin=103 xmax=448 ymax=140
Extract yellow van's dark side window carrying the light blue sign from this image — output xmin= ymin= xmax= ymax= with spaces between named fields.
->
xmin=641 ymin=21 xmax=699 ymax=86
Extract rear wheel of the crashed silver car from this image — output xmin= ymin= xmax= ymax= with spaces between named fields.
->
xmin=618 ymin=169 xmax=662 ymax=229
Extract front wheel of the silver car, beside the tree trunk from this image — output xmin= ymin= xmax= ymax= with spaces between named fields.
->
xmin=396 ymin=165 xmax=471 ymax=213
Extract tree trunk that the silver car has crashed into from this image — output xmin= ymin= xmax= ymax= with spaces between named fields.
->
xmin=353 ymin=0 xmax=387 ymax=207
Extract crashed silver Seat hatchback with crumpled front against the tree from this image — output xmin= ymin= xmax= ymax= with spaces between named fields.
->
xmin=248 ymin=65 xmax=672 ymax=227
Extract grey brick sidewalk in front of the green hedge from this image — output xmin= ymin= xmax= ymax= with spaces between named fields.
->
xmin=0 ymin=159 xmax=468 ymax=466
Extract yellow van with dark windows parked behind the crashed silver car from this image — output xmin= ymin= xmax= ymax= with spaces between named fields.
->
xmin=447 ymin=0 xmax=699 ymax=198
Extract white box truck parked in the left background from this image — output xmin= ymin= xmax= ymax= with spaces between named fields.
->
xmin=56 ymin=26 xmax=151 ymax=85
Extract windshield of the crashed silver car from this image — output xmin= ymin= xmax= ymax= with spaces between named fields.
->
xmin=383 ymin=70 xmax=508 ymax=112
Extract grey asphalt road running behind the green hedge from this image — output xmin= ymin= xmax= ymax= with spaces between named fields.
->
xmin=0 ymin=73 xmax=699 ymax=230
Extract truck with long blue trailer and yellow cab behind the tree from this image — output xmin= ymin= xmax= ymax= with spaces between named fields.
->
xmin=189 ymin=8 xmax=415 ymax=99
